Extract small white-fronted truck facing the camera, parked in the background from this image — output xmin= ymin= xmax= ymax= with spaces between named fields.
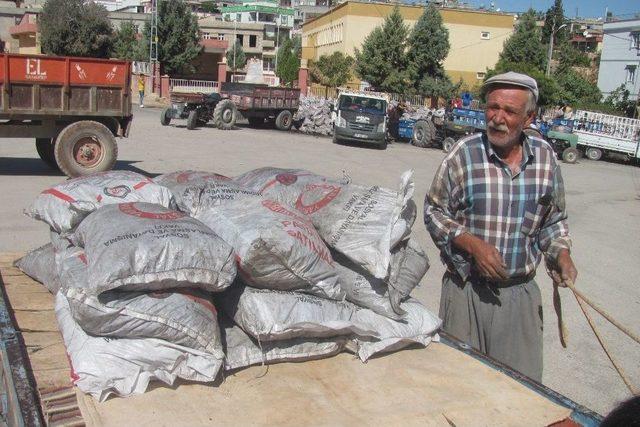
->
xmin=333 ymin=91 xmax=389 ymax=150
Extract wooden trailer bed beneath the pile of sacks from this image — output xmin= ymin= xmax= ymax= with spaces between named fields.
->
xmin=0 ymin=253 xmax=598 ymax=427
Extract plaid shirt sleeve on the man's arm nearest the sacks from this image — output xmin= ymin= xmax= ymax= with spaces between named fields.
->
xmin=424 ymin=159 xmax=469 ymax=278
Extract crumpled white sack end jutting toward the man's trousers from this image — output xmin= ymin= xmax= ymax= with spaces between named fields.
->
xmin=354 ymin=298 xmax=442 ymax=362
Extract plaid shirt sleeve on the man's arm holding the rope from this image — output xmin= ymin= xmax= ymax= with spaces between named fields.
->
xmin=538 ymin=165 xmax=571 ymax=262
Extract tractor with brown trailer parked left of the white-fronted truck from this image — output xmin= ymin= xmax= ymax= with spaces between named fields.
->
xmin=160 ymin=82 xmax=300 ymax=131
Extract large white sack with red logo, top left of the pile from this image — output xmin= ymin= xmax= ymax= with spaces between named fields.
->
xmin=73 ymin=203 xmax=236 ymax=295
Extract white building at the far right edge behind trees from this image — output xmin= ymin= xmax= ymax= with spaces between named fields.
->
xmin=598 ymin=18 xmax=640 ymax=100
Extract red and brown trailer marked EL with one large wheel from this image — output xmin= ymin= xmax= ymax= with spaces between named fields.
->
xmin=0 ymin=53 xmax=133 ymax=177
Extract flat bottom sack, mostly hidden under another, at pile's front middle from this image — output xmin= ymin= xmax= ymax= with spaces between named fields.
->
xmin=221 ymin=316 xmax=345 ymax=371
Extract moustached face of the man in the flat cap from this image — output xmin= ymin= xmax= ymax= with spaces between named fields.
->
xmin=485 ymin=87 xmax=533 ymax=148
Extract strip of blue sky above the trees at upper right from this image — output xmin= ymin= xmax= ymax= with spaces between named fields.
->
xmin=462 ymin=0 xmax=640 ymax=19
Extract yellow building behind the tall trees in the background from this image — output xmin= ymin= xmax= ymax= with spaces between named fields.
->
xmin=302 ymin=1 xmax=516 ymax=86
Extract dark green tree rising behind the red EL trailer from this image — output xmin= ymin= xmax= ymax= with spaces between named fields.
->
xmin=38 ymin=0 xmax=113 ymax=58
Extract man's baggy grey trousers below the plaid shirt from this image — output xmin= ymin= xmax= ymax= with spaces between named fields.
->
xmin=440 ymin=272 xmax=542 ymax=382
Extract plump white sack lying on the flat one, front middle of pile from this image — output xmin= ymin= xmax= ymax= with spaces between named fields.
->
xmin=216 ymin=283 xmax=376 ymax=341
